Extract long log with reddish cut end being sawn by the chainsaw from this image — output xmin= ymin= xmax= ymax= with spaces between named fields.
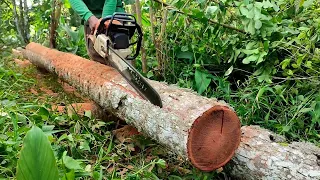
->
xmin=23 ymin=43 xmax=240 ymax=171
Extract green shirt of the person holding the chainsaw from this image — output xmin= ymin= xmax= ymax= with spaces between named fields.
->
xmin=69 ymin=0 xmax=125 ymax=21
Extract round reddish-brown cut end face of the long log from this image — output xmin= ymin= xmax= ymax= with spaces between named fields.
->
xmin=187 ymin=106 xmax=241 ymax=171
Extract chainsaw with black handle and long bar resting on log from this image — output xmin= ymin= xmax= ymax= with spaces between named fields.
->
xmin=93 ymin=13 xmax=162 ymax=108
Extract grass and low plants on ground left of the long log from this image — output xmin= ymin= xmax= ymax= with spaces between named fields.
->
xmin=0 ymin=47 xmax=224 ymax=180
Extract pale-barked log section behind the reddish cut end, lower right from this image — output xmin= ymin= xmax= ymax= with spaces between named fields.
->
xmin=228 ymin=126 xmax=320 ymax=180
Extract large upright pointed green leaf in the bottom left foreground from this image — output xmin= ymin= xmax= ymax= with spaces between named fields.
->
xmin=17 ymin=126 xmax=59 ymax=180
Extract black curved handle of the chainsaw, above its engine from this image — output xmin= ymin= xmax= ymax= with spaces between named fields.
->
xmin=97 ymin=12 xmax=143 ymax=60
